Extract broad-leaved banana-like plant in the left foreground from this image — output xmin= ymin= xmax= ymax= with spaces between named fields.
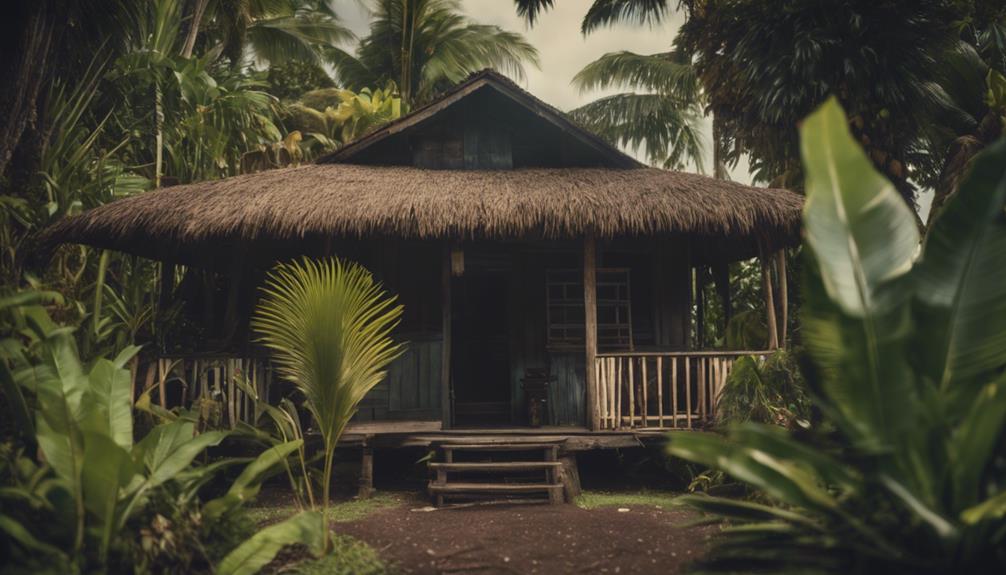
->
xmin=0 ymin=293 xmax=303 ymax=572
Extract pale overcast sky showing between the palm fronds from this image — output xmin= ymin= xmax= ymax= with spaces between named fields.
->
xmin=334 ymin=0 xmax=750 ymax=183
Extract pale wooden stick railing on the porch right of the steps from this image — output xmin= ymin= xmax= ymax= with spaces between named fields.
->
xmin=595 ymin=351 xmax=771 ymax=429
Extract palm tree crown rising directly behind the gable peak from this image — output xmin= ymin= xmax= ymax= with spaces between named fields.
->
xmin=329 ymin=0 xmax=538 ymax=106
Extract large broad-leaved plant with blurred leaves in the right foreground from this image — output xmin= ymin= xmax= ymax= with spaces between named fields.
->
xmin=669 ymin=96 xmax=1006 ymax=573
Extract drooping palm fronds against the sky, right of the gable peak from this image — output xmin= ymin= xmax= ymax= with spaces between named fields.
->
xmin=569 ymin=51 xmax=708 ymax=171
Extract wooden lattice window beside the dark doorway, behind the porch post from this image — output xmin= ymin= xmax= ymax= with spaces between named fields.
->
xmin=545 ymin=267 xmax=633 ymax=351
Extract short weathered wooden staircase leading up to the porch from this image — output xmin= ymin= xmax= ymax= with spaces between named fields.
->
xmin=429 ymin=441 xmax=564 ymax=507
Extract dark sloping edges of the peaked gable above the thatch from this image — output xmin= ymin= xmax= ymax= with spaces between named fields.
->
xmin=317 ymin=68 xmax=645 ymax=168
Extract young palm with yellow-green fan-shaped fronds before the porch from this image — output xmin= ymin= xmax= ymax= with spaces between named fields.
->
xmin=252 ymin=257 xmax=404 ymax=548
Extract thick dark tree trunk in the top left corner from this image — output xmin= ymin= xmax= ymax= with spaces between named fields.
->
xmin=0 ymin=1 xmax=55 ymax=184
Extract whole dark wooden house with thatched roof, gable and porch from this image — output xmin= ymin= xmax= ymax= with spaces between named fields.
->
xmin=45 ymin=70 xmax=802 ymax=502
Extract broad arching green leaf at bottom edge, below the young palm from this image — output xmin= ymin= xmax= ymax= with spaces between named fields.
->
xmin=216 ymin=511 xmax=327 ymax=575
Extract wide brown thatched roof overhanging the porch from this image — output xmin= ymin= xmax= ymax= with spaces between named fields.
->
xmin=42 ymin=164 xmax=803 ymax=258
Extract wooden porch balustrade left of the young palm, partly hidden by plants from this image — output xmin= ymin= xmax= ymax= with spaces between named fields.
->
xmin=143 ymin=355 xmax=276 ymax=428
